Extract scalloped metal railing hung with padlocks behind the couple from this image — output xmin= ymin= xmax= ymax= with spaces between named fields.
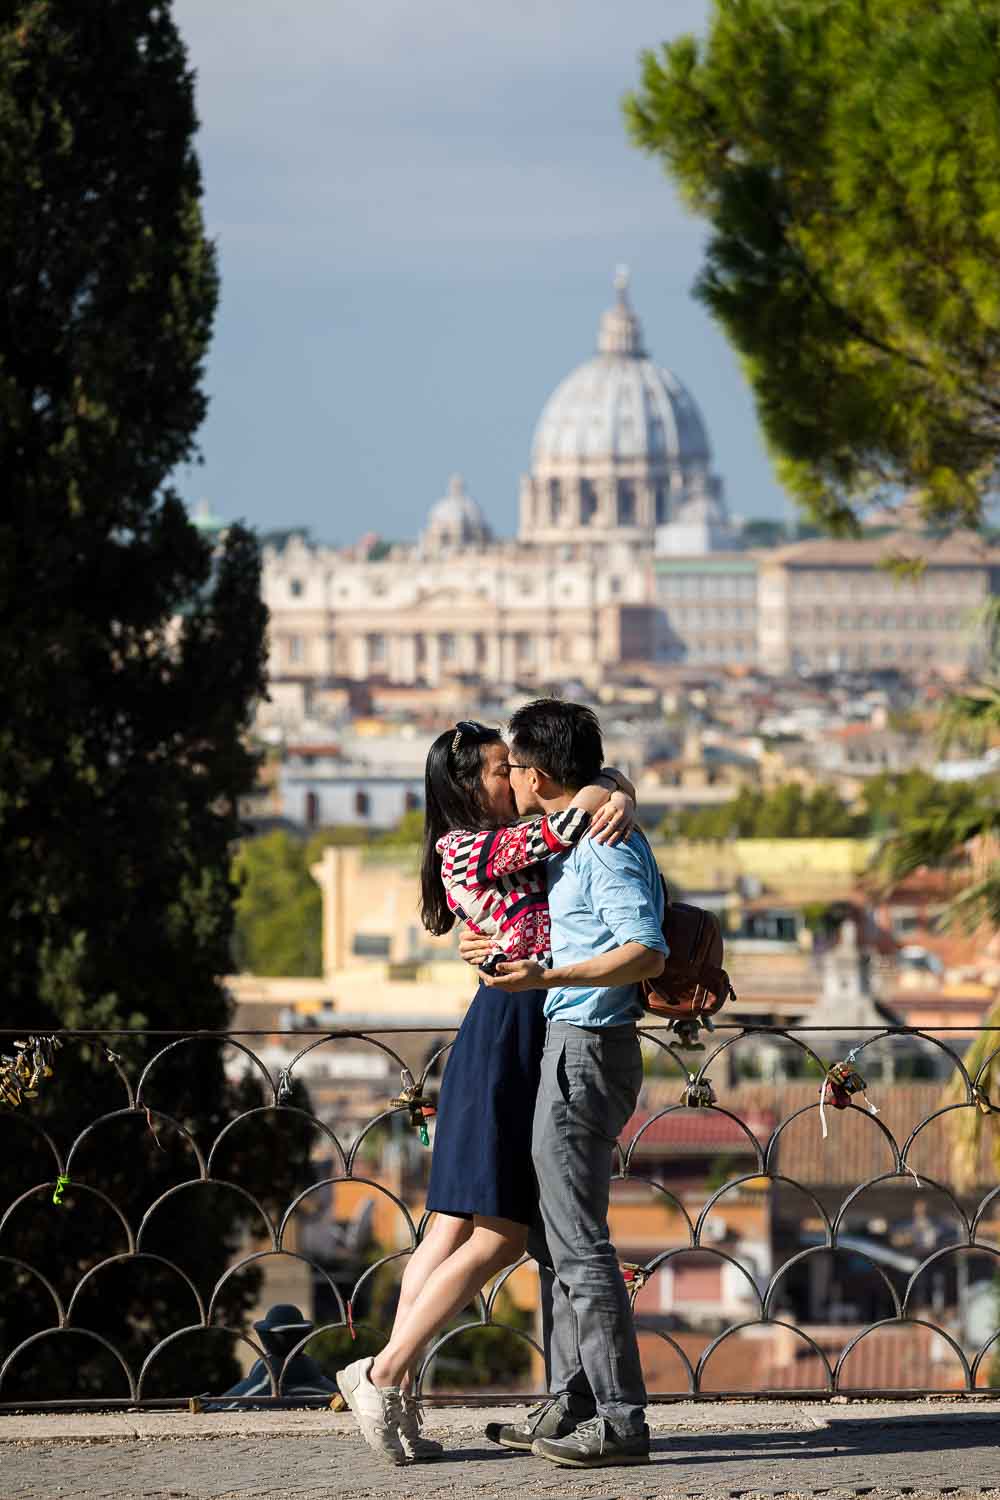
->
xmin=0 ymin=1023 xmax=1000 ymax=1410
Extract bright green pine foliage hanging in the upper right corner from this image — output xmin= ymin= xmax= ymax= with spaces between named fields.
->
xmin=625 ymin=0 xmax=1000 ymax=533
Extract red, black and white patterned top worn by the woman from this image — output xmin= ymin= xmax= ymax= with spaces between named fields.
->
xmin=436 ymin=807 xmax=591 ymax=968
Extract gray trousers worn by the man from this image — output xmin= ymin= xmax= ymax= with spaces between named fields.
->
xmin=528 ymin=1022 xmax=646 ymax=1437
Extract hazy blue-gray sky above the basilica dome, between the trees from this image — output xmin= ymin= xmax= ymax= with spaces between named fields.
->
xmin=174 ymin=0 xmax=787 ymax=543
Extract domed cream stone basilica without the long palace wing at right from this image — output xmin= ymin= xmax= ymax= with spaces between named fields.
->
xmin=262 ymin=272 xmax=738 ymax=686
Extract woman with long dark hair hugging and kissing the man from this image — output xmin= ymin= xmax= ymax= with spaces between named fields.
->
xmin=337 ymin=720 xmax=634 ymax=1463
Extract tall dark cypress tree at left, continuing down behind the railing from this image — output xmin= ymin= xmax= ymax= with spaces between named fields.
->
xmin=0 ymin=0 xmax=313 ymax=1400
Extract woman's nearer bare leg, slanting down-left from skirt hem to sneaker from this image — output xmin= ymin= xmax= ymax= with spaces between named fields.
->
xmin=370 ymin=1215 xmax=528 ymax=1386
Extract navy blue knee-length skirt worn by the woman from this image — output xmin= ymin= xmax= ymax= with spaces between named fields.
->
xmin=427 ymin=984 xmax=546 ymax=1224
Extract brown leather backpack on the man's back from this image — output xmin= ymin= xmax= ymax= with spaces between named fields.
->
xmin=642 ymin=876 xmax=736 ymax=1022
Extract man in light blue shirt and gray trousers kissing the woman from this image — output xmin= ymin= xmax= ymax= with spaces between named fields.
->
xmin=484 ymin=699 xmax=667 ymax=1469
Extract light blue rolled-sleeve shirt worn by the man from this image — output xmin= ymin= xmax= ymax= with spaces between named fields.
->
xmin=544 ymin=833 xmax=667 ymax=1026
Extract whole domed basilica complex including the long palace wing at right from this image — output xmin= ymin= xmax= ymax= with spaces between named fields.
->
xmin=262 ymin=273 xmax=1000 ymax=699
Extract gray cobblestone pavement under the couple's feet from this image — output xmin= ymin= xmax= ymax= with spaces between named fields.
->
xmin=0 ymin=1401 xmax=1000 ymax=1500
